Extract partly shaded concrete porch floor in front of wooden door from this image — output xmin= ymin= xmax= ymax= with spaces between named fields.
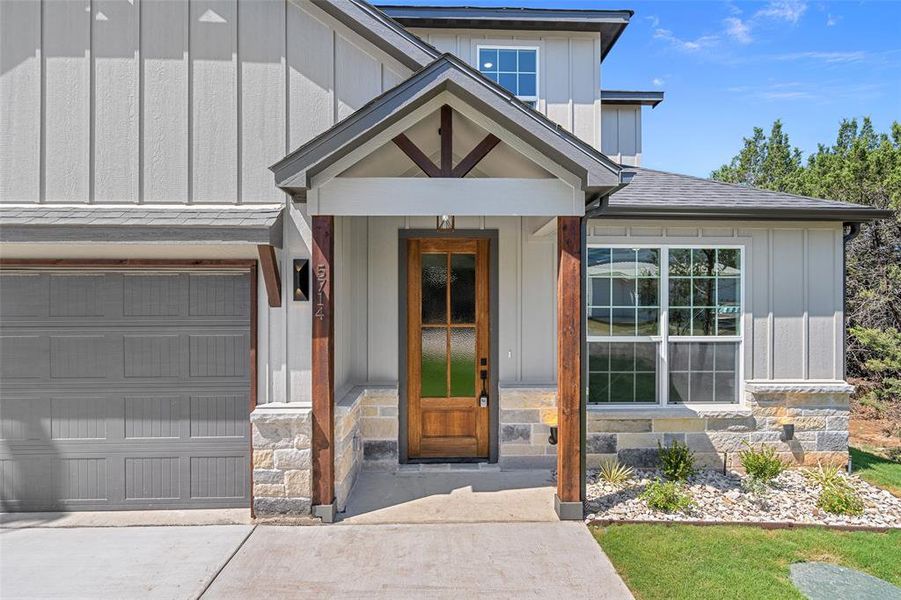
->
xmin=339 ymin=470 xmax=558 ymax=525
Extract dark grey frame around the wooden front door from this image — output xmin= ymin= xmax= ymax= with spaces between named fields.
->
xmin=397 ymin=229 xmax=500 ymax=464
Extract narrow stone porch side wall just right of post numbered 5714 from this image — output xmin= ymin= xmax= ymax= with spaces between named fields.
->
xmin=335 ymin=388 xmax=363 ymax=512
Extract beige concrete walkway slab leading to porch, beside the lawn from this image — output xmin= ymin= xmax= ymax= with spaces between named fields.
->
xmin=203 ymin=522 xmax=632 ymax=600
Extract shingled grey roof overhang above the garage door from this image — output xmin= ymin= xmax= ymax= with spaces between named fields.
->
xmin=0 ymin=205 xmax=283 ymax=247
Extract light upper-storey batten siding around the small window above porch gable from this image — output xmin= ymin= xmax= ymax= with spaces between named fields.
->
xmin=411 ymin=28 xmax=601 ymax=148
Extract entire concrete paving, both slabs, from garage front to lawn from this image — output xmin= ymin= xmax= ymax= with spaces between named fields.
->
xmin=0 ymin=522 xmax=632 ymax=600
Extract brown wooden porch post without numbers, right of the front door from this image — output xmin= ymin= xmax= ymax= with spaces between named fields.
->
xmin=554 ymin=217 xmax=584 ymax=520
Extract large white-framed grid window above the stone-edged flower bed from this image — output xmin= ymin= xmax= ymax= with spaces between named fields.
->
xmin=587 ymin=245 xmax=742 ymax=405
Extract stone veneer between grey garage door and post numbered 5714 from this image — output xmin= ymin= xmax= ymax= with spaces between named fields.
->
xmin=250 ymin=404 xmax=313 ymax=518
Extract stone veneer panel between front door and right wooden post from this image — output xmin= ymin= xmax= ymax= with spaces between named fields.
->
xmin=498 ymin=386 xmax=557 ymax=469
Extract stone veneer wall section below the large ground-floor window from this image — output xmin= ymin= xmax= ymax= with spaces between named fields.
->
xmin=586 ymin=382 xmax=853 ymax=469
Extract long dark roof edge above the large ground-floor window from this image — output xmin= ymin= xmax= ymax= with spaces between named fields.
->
xmin=585 ymin=205 xmax=894 ymax=223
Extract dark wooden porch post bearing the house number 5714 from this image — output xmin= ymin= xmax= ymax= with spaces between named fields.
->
xmin=311 ymin=215 xmax=336 ymax=523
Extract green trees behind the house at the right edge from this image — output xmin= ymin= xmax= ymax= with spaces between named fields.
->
xmin=711 ymin=118 xmax=901 ymax=410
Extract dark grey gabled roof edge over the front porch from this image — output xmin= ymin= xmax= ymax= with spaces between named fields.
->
xmin=270 ymin=54 xmax=621 ymax=200
